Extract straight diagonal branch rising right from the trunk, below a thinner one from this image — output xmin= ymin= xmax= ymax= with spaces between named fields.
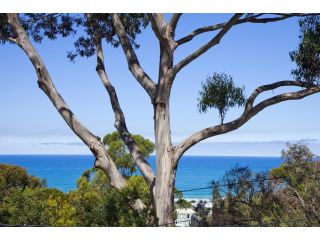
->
xmin=174 ymin=13 xmax=243 ymax=74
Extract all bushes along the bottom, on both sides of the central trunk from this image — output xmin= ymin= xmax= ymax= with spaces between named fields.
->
xmin=0 ymin=142 xmax=320 ymax=226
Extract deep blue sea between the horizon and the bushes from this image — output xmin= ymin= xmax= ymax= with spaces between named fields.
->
xmin=0 ymin=155 xmax=281 ymax=198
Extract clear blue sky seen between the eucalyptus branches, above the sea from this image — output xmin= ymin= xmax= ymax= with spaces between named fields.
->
xmin=0 ymin=14 xmax=320 ymax=156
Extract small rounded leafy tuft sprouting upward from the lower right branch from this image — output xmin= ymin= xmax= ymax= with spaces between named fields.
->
xmin=198 ymin=73 xmax=246 ymax=124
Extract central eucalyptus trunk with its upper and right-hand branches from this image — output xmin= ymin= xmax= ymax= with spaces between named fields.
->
xmin=112 ymin=14 xmax=320 ymax=226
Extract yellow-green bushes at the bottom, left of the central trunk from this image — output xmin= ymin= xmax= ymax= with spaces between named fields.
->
xmin=0 ymin=165 xmax=157 ymax=226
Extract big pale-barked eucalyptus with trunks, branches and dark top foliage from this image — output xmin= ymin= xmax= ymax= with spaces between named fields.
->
xmin=0 ymin=13 xmax=320 ymax=226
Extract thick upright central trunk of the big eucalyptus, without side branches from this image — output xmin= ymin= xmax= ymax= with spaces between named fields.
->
xmin=153 ymin=39 xmax=176 ymax=226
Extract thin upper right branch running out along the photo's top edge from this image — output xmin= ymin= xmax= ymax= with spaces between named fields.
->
xmin=176 ymin=13 xmax=312 ymax=46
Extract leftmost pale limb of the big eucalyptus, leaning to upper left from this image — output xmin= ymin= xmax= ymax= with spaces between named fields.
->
xmin=7 ymin=14 xmax=131 ymax=193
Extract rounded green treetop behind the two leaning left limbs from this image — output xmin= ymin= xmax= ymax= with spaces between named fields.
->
xmin=103 ymin=132 xmax=154 ymax=177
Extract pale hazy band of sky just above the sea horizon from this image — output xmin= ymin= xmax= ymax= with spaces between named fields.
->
xmin=0 ymin=139 xmax=320 ymax=157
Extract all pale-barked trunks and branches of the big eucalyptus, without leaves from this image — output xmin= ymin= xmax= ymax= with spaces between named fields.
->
xmin=4 ymin=14 xmax=320 ymax=226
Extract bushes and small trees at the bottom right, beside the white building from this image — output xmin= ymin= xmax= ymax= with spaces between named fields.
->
xmin=193 ymin=143 xmax=320 ymax=226
